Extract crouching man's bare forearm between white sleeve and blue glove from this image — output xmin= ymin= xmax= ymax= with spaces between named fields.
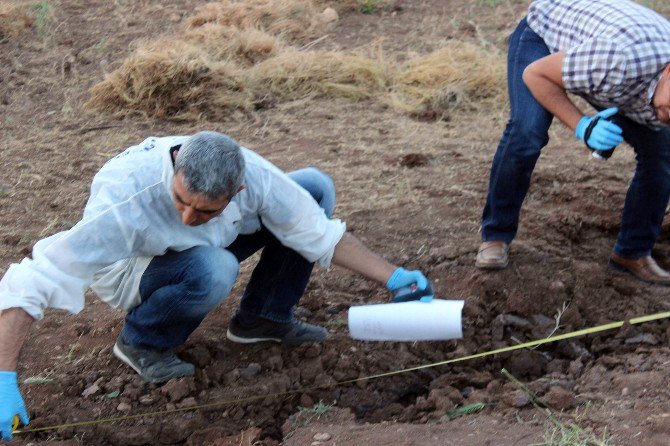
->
xmin=333 ymin=232 xmax=398 ymax=284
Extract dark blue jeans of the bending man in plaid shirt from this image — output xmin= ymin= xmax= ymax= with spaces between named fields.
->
xmin=482 ymin=19 xmax=670 ymax=258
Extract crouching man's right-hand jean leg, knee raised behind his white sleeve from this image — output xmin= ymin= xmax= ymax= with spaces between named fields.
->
xmin=227 ymin=168 xmax=335 ymax=323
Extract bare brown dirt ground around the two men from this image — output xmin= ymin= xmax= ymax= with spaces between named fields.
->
xmin=0 ymin=0 xmax=670 ymax=445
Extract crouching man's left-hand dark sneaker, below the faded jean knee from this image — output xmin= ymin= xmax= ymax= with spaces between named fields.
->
xmin=114 ymin=335 xmax=195 ymax=383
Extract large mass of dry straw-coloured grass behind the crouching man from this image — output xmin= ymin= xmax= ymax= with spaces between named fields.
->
xmin=88 ymin=0 xmax=505 ymax=119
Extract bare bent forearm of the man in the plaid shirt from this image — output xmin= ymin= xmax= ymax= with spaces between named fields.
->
xmin=523 ymin=51 xmax=584 ymax=130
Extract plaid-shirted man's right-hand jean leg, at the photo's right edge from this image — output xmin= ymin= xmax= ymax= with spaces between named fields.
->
xmin=614 ymin=116 xmax=670 ymax=259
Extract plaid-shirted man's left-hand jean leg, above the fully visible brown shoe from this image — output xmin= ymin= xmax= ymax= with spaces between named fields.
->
xmin=482 ymin=19 xmax=553 ymax=243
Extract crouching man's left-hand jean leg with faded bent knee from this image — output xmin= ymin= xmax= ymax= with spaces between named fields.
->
xmin=121 ymin=246 xmax=239 ymax=350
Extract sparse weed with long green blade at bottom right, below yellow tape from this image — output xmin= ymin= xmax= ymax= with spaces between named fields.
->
xmin=501 ymin=369 xmax=613 ymax=446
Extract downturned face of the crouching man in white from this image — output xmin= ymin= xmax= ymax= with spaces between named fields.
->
xmin=172 ymin=172 xmax=230 ymax=226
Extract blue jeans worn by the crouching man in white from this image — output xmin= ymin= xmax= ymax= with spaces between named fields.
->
xmin=121 ymin=168 xmax=335 ymax=349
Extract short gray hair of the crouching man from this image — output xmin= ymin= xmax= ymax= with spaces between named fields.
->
xmin=174 ymin=132 xmax=244 ymax=200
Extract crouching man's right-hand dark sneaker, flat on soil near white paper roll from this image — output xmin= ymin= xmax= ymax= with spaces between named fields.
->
xmin=226 ymin=316 xmax=328 ymax=346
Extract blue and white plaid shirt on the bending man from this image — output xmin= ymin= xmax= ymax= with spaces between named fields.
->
xmin=527 ymin=0 xmax=670 ymax=129
